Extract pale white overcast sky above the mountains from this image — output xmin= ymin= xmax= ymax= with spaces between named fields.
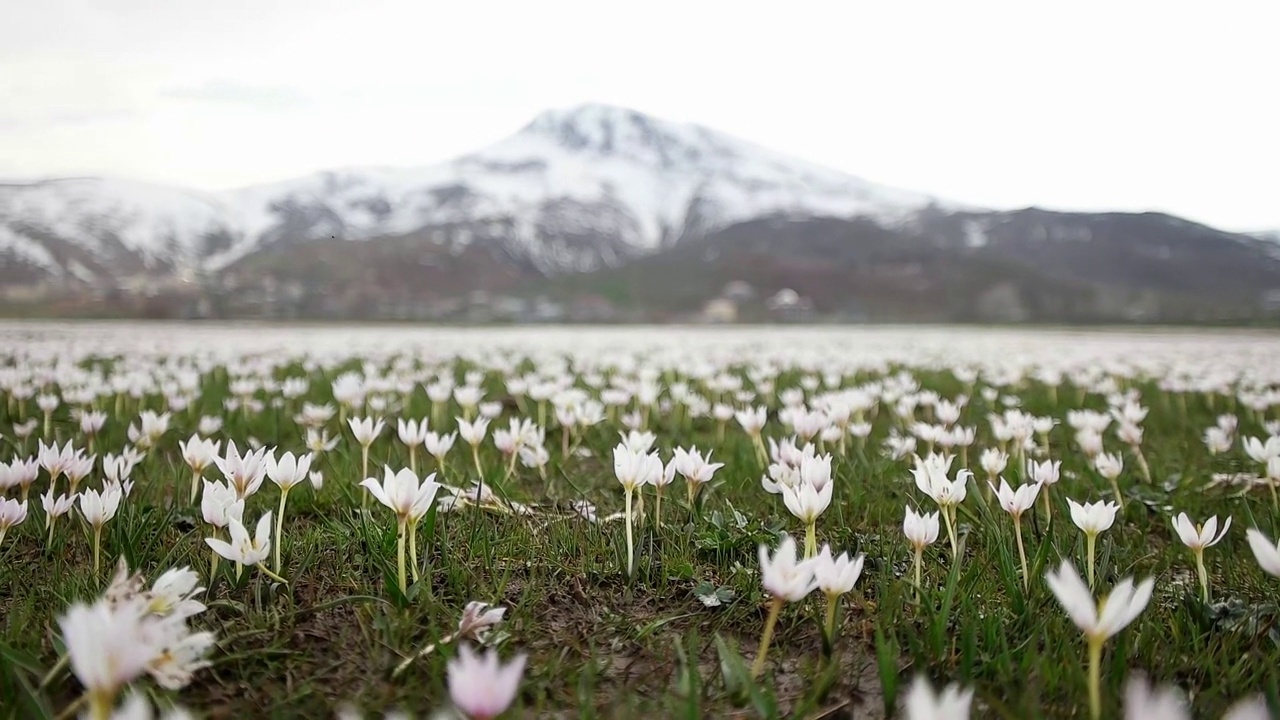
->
xmin=0 ymin=0 xmax=1280 ymax=229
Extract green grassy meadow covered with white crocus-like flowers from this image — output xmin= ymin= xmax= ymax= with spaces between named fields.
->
xmin=0 ymin=323 xmax=1280 ymax=720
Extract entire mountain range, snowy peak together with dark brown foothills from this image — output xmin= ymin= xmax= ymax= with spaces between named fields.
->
xmin=0 ymin=104 xmax=1280 ymax=322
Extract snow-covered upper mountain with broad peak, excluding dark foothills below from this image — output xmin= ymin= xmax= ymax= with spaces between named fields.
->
xmin=0 ymin=105 xmax=959 ymax=282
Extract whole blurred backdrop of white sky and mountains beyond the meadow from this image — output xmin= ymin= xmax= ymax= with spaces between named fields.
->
xmin=0 ymin=0 xmax=1280 ymax=325
